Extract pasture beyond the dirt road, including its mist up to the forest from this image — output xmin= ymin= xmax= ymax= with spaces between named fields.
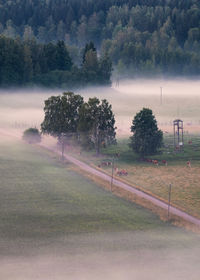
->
xmin=0 ymin=79 xmax=200 ymax=218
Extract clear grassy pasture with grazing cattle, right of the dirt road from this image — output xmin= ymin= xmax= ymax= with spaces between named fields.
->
xmin=66 ymin=134 xmax=200 ymax=218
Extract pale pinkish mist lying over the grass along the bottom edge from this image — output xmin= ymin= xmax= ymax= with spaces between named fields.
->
xmin=0 ymin=230 xmax=200 ymax=280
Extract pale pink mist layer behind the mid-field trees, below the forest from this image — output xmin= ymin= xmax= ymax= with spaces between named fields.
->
xmin=0 ymin=79 xmax=200 ymax=135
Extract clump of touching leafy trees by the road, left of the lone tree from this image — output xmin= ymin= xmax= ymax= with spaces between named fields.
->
xmin=41 ymin=92 xmax=116 ymax=155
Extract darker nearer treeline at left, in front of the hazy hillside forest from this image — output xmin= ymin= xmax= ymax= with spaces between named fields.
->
xmin=0 ymin=36 xmax=112 ymax=88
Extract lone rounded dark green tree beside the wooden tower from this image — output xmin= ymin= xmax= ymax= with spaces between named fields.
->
xmin=130 ymin=108 xmax=163 ymax=156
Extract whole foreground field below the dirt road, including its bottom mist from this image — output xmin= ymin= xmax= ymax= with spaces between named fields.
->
xmin=0 ymin=134 xmax=200 ymax=280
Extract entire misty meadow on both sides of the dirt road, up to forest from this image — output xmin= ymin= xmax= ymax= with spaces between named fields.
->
xmin=0 ymin=80 xmax=200 ymax=280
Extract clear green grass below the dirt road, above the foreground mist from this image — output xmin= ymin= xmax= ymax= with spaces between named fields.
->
xmin=0 ymin=137 xmax=171 ymax=238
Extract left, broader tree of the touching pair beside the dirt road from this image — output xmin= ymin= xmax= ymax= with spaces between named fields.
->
xmin=41 ymin=92 xmax=83 ymax=138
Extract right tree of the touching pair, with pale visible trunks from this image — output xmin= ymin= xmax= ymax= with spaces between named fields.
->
xmin=79 ymin=97 xmax=116 ymax=155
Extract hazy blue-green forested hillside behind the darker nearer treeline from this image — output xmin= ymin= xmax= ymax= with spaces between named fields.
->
xmin=0 ymin=0 xmax=200 ymax=76
